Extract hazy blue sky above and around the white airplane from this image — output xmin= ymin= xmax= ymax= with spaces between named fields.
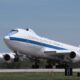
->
xmin=0 ymin=0 xmax=80 ymax=52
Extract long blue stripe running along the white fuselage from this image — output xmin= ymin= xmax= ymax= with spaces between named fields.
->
xmin=10 ymin=37 xmax=67 ymax=50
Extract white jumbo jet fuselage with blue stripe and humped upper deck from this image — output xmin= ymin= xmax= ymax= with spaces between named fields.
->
xmin=4 ymin=29 xmax=80 ymax=61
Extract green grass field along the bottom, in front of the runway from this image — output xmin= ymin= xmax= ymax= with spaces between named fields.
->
xmin=0 ymin=72 xmax=80 ymax=80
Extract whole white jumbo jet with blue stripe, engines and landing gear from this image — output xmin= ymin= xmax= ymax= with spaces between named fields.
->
xmin=4 ymin=28 xmax=80 ymax=68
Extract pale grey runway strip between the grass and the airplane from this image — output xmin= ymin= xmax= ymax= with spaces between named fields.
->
xmin=0 ymin=69 xmax=80 ymax=72
